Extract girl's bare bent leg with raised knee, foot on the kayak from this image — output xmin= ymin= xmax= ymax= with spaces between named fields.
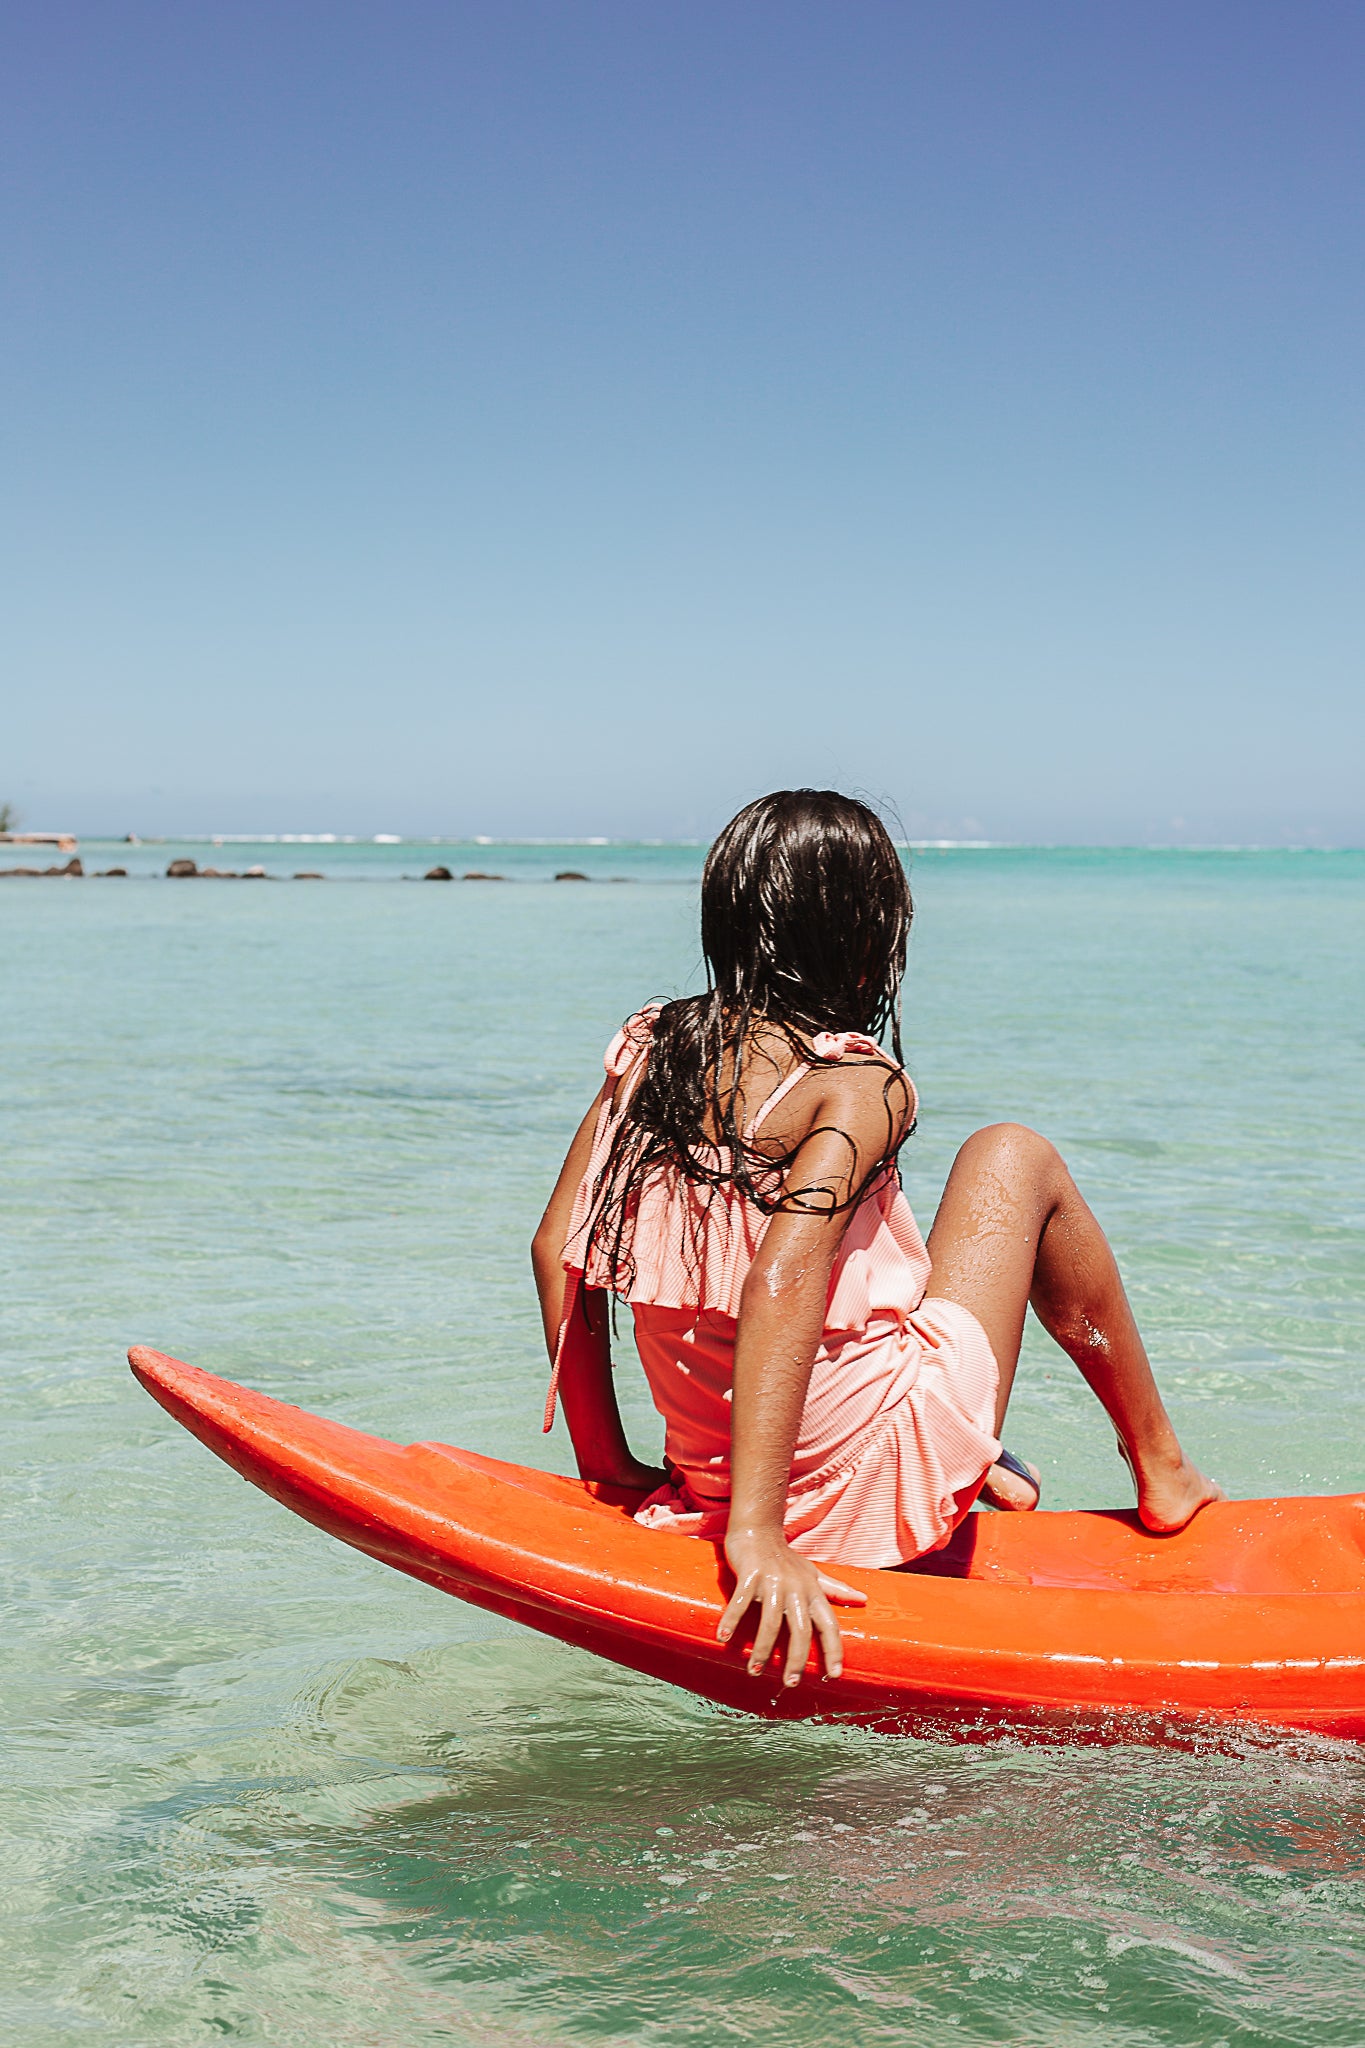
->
xmin=929 ymin=1124 xmax=1224 ymax=1530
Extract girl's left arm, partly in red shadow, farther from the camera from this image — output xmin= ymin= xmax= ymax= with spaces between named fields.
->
xmin=530 ymin=1081 xmax=663 ymax=1489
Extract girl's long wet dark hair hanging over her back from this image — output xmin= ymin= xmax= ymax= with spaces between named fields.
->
xmin=589 ymin=788 xmax=913 ymax=1294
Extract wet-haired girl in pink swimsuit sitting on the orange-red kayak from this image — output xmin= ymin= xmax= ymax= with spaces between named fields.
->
xmin=532 ymin=791 xmax=1222 ymax=1686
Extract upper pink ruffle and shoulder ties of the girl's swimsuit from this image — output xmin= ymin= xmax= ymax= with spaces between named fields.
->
xmin=563 ymin=1004 xmax=929 ymax=1331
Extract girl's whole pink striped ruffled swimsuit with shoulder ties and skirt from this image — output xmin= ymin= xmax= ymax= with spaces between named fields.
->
xmin=561 ymin=1004 xmax=999 ymax=1565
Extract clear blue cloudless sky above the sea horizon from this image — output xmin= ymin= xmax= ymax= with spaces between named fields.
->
xmin=0 ymin=0 xmax=1365 ymax=844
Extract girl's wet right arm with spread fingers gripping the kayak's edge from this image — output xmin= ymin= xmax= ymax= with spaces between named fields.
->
xmin=716 ymin=1067 xmax=911 ymax=1686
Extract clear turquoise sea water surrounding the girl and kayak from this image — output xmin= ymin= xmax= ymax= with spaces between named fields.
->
xmin=0 ymin=844 xmax=1365 ymax=2048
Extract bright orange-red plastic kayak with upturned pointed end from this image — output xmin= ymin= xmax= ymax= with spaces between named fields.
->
xmin=129 ymin=1346 xmax=1365 ymax=1739
